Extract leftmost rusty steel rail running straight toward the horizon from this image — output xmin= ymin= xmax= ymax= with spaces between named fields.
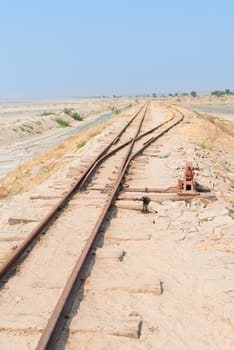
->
xmin=0 ymin=104 xmax=146 ymax=283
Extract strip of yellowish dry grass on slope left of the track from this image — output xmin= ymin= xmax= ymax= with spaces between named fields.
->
xmin=0 ymin=115 xmax=120 ymax=198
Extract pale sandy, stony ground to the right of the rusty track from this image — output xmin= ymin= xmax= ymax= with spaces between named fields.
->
xmin=60 ymin=104 xmax=234 ymax=350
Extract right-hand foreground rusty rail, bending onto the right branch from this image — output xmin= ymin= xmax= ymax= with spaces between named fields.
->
xmin=35 ymin=108 xmax=184 ymax=350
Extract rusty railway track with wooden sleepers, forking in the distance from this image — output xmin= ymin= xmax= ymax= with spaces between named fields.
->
xmin=0 ymin=105 xmax=183 ymax=350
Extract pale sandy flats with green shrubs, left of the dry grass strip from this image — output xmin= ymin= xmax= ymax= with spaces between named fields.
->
xmin=0 ymin=99 xmax=134 ymax=178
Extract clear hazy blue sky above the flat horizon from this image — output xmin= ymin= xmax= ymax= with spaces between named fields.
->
xmin=0 ymin=0 xmax=234 ymax=98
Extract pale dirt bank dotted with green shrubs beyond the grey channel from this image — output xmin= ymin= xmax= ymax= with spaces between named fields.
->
xmin=0 ymin=99 xmax=131 ymax=145
